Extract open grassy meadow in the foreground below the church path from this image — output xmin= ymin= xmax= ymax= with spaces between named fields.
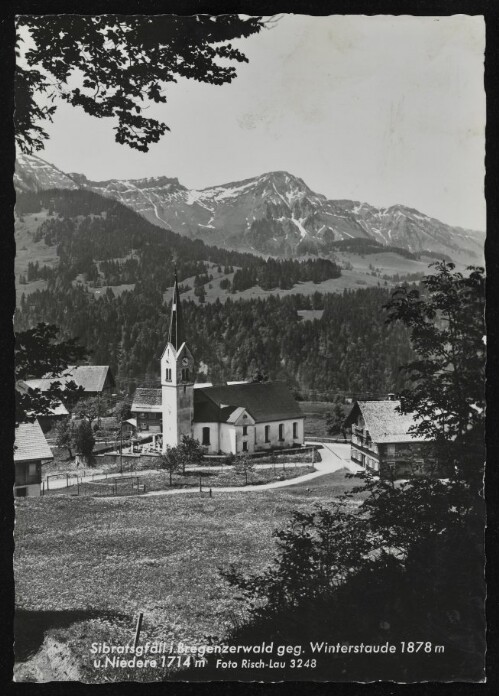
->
xmin=14 ymin=470 xmax=355 ymax=681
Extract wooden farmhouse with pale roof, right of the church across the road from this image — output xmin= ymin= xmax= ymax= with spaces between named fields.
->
xmin=345 ymin=399 xmax=436 ymax=478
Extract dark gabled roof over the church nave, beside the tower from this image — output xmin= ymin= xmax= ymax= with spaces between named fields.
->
xmin=194 ymin=382 xmax=303 ymax=423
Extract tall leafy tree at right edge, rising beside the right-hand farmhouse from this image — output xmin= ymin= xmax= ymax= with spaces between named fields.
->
xmin=386 ymin=261 xmax=485 ymax=487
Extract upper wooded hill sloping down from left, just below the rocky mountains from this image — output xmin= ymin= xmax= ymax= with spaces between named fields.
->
xmin=16 ymin=190 xmax=341 ymax=291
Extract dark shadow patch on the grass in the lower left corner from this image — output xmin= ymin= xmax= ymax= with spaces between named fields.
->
xmin=14 ymin=609 xmax=127 ymax=662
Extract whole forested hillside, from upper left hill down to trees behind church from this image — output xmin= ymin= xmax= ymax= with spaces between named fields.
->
xmin=16 ymin=185 xmax=416 ymax=394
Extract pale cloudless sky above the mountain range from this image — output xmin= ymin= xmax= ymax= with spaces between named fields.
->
xmin=31 ymin=15 xmax=485 ymax=229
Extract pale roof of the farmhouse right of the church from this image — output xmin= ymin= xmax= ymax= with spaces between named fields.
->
xmin=347 ymin=400 xmax=427 ymax=443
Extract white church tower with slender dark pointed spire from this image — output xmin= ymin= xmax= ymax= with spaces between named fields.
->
xmin=161 ymin=272 xmax=194 ymax=451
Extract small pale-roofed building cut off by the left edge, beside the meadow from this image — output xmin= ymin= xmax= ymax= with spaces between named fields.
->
xmin=14 ymin=420 xmax=54 ymax=498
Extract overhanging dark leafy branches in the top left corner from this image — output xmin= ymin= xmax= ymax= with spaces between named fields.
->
xmin=15 ymin=14 xmax=263 ymax=153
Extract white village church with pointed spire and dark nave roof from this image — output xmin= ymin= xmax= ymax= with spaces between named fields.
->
xmin=132 ymin=276 xmax=304 ymax=454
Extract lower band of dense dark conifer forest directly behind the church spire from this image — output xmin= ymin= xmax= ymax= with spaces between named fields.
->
xmin=16 ymin=285 xmax=411 ymax=394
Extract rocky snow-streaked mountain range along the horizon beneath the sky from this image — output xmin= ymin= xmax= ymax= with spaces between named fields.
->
xmin=16 ymin=155 xmax=485 ymax=262
